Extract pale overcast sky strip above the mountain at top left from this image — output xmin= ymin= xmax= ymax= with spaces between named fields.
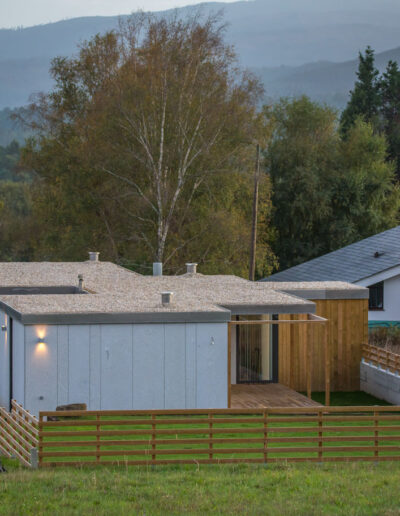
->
xmin=0 ymin=0 xmax=238 ymax=28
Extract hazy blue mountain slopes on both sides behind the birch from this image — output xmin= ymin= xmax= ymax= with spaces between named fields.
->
xmin=0 ymin=0 xmax=400 ymax=139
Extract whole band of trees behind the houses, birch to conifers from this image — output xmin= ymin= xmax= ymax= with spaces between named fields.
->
xmin=0 ymin=15 xmax=400 ymax=278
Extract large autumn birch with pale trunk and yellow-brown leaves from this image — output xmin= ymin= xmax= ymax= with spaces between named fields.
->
xmin=24 ymin=15 xmax=268 ymax=273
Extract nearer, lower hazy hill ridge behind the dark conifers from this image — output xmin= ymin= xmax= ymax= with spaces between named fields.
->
xmin=253 ymin=47 xmax=400 ymax=109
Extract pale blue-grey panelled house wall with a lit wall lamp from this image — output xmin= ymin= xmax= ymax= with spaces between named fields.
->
xmin=25 ymin=323 xmax=227 ymax=413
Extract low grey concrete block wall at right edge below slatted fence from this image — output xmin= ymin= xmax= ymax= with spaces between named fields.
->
xmin=360 ymin=361 xmax=400 ymax=405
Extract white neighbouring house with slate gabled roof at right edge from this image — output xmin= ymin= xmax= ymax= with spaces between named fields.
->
xmin=263 ymin=226 xmax=400 ymax=327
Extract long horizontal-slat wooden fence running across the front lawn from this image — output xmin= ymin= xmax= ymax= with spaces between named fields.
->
xmin=39 ymin=406 xmax=400 ymax=467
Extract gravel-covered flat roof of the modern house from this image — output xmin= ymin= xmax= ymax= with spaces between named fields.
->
xmin=0 ymin=261 xmax=368 ymax=324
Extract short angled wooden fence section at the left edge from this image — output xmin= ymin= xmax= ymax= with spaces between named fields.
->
xmin=0 ymin=400 xmax=39 ymax=467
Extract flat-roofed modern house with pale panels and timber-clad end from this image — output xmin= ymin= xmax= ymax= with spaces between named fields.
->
xmin=0 ymin=253 xmax=368 ymax=414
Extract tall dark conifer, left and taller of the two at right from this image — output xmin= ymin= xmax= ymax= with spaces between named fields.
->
xmin=340 ymin=46 xmax=381 ymax=136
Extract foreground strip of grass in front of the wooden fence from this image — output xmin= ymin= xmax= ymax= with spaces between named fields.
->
xmin=0 ymin=460 xmax=400 ymax=516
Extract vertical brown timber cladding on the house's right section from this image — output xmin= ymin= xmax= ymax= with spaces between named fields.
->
xmin=279 ymin=299 xmax=368 ymax=391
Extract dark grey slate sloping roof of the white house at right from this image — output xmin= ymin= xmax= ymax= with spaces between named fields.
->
xmin=262 ymin=226 xmax=400 ymax=283
